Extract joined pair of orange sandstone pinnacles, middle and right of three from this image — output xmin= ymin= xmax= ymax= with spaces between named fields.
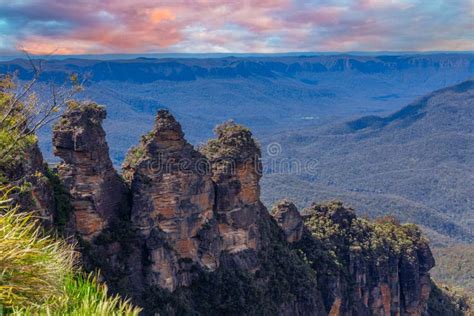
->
xmin=123 ymin=115 xmax=266 ymax=291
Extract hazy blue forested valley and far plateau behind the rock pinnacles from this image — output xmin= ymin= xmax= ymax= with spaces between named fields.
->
xmin=0 ymin=53 xmax=474 ymax=165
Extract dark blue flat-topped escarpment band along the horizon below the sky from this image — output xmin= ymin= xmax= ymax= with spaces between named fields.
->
xmin=0 ymin=54 xmax=474 ymax=83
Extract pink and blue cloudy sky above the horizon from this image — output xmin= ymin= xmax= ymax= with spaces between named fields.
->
xmin=0 ymin=0 xmax=474 ymax=55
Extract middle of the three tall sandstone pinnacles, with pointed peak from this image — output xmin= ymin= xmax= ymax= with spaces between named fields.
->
xmin=123 ymin=110 xmax=220 ymax=290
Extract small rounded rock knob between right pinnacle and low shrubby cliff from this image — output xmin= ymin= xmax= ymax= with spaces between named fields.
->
xmin=272 ymin=200 xmax=304 ymax=243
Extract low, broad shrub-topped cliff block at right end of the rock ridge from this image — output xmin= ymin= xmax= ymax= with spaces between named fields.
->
xmin=280 ymin=202 xmax=434 ymax=315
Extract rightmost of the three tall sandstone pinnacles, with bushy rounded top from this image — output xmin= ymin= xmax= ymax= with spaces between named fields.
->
xmin=201 ymin=122 xmax=267 ymax=269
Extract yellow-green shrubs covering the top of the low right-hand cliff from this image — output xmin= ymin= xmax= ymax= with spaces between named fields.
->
xmin=294 ymin=202 xmax=427 ymax=288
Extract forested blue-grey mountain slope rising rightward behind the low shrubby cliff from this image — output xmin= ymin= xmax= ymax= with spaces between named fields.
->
xmin=263 ymin=80 xmax=474 ymax=245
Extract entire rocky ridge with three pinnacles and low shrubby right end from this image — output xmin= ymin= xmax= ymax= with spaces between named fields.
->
xmin=47 ymin=104 xmax=434 ymax=315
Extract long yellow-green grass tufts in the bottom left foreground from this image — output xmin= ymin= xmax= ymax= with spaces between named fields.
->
xmin=0 ymin=188 xmax=140 ymax=316
